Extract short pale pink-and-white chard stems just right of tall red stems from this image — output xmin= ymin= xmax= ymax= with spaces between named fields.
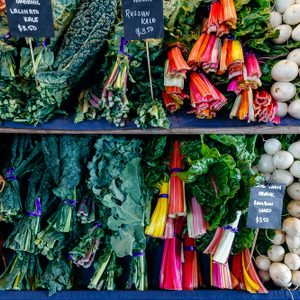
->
xmin=187 ymin=197 xmax=207 ymax=239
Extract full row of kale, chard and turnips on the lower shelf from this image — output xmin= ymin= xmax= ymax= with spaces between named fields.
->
xmin=0 ymin=135 xmax=292 ymax=295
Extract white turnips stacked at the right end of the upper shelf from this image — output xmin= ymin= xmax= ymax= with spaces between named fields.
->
xmin=270 ymin=0 xmax=300 ymax=119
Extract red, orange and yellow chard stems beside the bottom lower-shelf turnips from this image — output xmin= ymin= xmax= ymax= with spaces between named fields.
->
xmin=231 ymin=249 xmax=268 ymax=294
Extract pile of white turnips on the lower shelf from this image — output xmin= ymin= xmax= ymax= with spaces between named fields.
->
xmin=255 ymin=138 xmax=300 ymax=287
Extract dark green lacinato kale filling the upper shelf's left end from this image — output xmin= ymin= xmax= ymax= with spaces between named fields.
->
xmin=0 ymin=0 xmax=116 ymax=124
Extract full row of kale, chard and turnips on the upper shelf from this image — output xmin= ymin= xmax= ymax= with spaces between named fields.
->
xmin=0 ymin=0 xmax=300 ymax=128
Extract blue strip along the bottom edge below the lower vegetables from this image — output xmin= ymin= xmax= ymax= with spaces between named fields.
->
xmin=0 ymin=290 xmax=300 ymax=300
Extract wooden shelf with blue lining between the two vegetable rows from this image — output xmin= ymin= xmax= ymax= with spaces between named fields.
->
xmin=0 ymin=113 xmax=300 ymax=135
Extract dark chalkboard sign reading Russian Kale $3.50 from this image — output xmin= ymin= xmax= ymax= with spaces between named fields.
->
xmin=122 ymin=0 xmax=164 ymax=40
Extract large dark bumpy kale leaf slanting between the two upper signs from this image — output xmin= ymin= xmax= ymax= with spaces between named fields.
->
xmin=54 ymin=0 xmax=117 ymax=84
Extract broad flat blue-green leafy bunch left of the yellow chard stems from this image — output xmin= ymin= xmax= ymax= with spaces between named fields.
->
xmin=89 ymin=137 xmax=148 ymax=290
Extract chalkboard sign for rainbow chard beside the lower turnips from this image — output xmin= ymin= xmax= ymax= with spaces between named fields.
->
xmin=247 ymin=183 xmax=285 ymax=229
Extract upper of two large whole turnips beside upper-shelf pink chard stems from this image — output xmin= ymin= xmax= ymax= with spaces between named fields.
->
xmin=271 ymin=59 xmax=299 ymax=82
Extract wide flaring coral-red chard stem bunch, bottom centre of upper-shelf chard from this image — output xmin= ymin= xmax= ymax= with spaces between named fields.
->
xmin=190 ymin=72 xmax=227 ymax=119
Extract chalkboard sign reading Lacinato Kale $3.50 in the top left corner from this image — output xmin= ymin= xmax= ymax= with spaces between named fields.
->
xmin=6 ymin=0 xmax=54 ymax=37
